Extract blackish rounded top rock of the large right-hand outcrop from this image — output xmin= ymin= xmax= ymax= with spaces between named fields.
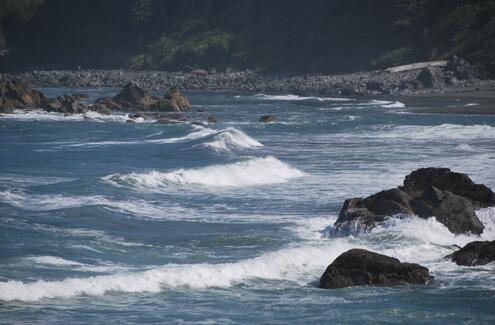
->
xmin=403 ymin=167 xmax=495 ymax=209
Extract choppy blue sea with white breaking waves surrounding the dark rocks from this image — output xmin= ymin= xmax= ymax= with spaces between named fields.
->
xmin=0 ymin=89 xmax=495 ymax=324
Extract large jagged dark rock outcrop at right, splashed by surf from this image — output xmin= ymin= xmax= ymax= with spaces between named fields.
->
xmin=334 ymin=168 xmax=495 ymax=234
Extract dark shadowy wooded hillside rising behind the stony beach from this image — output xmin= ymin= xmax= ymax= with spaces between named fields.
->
xmin=0 ymin=0 xmax=495 ymax=77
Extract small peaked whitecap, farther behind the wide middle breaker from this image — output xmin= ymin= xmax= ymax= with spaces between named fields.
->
xmin=202 ymin=127 xmax=263 ymax=151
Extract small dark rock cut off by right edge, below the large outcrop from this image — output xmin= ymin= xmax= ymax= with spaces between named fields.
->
xmin=446 ymin=240 xmax=495 ymax=266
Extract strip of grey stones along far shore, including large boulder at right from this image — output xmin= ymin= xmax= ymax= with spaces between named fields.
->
xmin=0 ymin=57 xmax=495 ymax=96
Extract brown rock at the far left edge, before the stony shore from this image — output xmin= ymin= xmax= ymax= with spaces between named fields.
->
xmin=0 ymin=80 xmax=46 ymax=113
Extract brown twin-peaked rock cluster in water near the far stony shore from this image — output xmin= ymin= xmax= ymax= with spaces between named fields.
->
xmin=93 ymin=81 xmax=190 ymax=112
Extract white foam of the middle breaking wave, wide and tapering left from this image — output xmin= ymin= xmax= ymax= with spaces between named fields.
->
xmin=103 ymin=156 xmax=304 ymax=190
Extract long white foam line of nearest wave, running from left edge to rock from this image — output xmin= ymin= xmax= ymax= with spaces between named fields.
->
xmin=0 ymin=240 xmax=351 ymax=301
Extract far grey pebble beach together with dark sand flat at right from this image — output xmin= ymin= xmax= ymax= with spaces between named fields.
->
xmin=0 ymin=70 xmax=495 ymax=115
